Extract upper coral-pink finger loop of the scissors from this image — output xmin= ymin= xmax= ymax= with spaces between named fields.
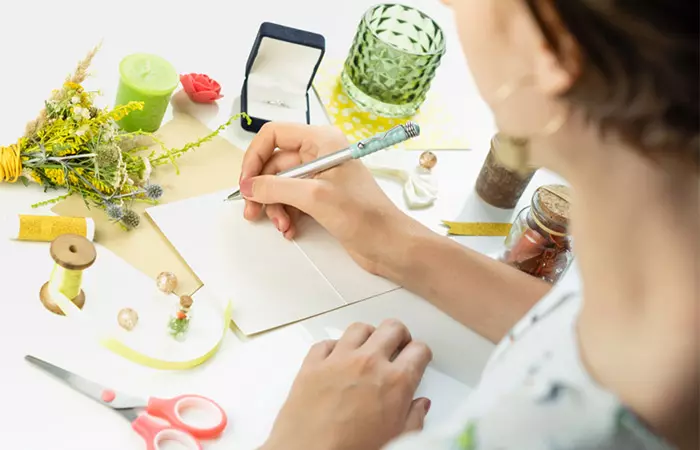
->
xmin=146 ymin=395 xmax=228 ymax=439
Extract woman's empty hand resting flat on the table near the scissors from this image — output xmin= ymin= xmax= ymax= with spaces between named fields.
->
xmin=261 ymin=320 xmax=432 ymax=450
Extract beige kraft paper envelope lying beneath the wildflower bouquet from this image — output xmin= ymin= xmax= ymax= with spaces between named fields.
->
xmin=52 ymin=112 xmax=244 ymax=295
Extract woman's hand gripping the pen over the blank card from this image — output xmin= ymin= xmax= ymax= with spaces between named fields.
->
xmin=240 ymin=123 xmax=412 ymax=275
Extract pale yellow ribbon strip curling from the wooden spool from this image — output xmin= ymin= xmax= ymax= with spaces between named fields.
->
xmin=51 ymin=284 xmax=233 ymax=370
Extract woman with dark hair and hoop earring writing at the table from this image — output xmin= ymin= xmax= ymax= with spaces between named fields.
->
xmin=241 ymin=0 xmax=700 ymax=450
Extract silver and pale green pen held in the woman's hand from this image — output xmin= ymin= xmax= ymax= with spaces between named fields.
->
xmin=226 ymin=122 xmax=420 ymax=201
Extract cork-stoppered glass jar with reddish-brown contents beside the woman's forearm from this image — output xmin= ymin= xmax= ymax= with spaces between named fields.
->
xmin=499 ymin=185 xmax=573 ymax=283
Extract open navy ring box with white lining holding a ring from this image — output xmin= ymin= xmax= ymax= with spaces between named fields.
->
xmin=241 ymin=22 xmax=326 ymax=133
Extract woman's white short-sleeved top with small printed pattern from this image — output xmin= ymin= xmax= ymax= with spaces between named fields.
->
xmin=387 ymin=268 xmax=672 ymax=450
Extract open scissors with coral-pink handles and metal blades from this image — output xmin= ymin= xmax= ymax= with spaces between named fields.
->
xmin=24 ymin=355 xmax=228 ymax=450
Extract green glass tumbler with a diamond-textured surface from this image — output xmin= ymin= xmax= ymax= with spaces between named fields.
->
xmin=340 ymin=4 xmax=445 ymax=117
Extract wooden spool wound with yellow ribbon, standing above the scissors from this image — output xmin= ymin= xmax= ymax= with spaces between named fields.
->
xmin=39 ymin=234 xmax=97 ymax=316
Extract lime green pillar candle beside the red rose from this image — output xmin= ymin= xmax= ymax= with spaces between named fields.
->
xmin=116 ymin=53 xmax=180 ymax=133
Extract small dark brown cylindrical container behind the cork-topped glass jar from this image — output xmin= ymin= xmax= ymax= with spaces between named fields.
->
xmin=476 ymin=134 xmax=537 ymax=209
